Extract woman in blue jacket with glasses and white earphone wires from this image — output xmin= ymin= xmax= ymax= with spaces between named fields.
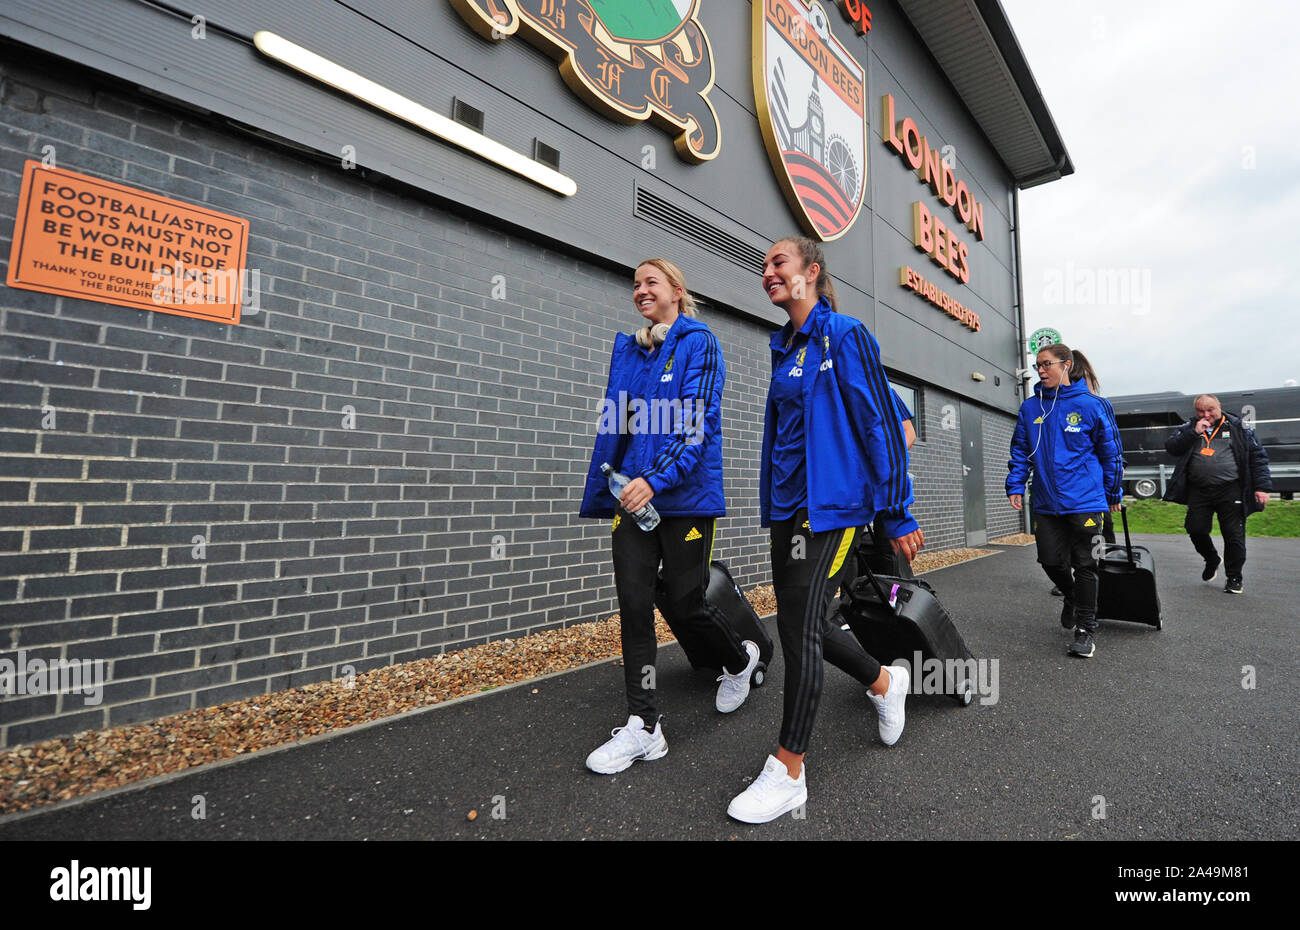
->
xmin=1006 ymin=343 xmax=1125 ymax=658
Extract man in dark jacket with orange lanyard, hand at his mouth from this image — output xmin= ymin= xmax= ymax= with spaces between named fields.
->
xmin=1165 ymin=394 xmax=1273 ymax=594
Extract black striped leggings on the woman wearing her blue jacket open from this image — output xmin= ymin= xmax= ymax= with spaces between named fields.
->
xmin=771 ymin=510 xmax=880 ymax=753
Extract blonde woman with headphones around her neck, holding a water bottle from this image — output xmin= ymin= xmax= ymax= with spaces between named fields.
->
xmin=581 ymin=259 xmax=759 ymax=775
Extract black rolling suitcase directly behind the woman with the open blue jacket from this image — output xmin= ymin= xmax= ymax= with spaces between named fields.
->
xmin=844 ymin=568 xmax=975 ymax=705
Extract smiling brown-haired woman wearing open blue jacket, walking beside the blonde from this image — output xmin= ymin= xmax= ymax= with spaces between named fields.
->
xmin=727 ymin=238 xmax=924 ymax=823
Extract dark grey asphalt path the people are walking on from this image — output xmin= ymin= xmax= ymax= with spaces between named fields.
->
xmin=0 ymin=536 xmax=1300 ymax=840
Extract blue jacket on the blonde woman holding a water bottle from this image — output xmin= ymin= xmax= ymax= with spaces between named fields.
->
xmin=579 ymin=315 xmax=727 ymax=516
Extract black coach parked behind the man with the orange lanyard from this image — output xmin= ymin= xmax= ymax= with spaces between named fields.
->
xmin=1108 ymin=388 xmax=1300 ymax=501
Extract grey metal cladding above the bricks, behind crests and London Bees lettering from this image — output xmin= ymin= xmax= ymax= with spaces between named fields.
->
xmin=0 ymin=0 xmax=1017 ymax=410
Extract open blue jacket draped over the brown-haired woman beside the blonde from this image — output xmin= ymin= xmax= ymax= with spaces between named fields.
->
xmin=759 ymin=298 xmax=917 ymax=538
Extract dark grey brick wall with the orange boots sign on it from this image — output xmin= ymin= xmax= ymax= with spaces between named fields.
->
xmin=0 ymin=49 xmax=1008 ymax=747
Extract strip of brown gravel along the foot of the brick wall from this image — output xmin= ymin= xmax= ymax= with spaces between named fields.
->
xmin=0 ymin=537 xmax=993 ymax=814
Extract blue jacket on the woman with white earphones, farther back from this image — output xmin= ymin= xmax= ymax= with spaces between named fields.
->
xmin=1006 ymin=381 xmax=1125 ymax=515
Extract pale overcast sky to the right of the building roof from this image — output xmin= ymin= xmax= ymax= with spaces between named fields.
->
xmin=1002 ymin=0 xmax=1300 ymax=395
